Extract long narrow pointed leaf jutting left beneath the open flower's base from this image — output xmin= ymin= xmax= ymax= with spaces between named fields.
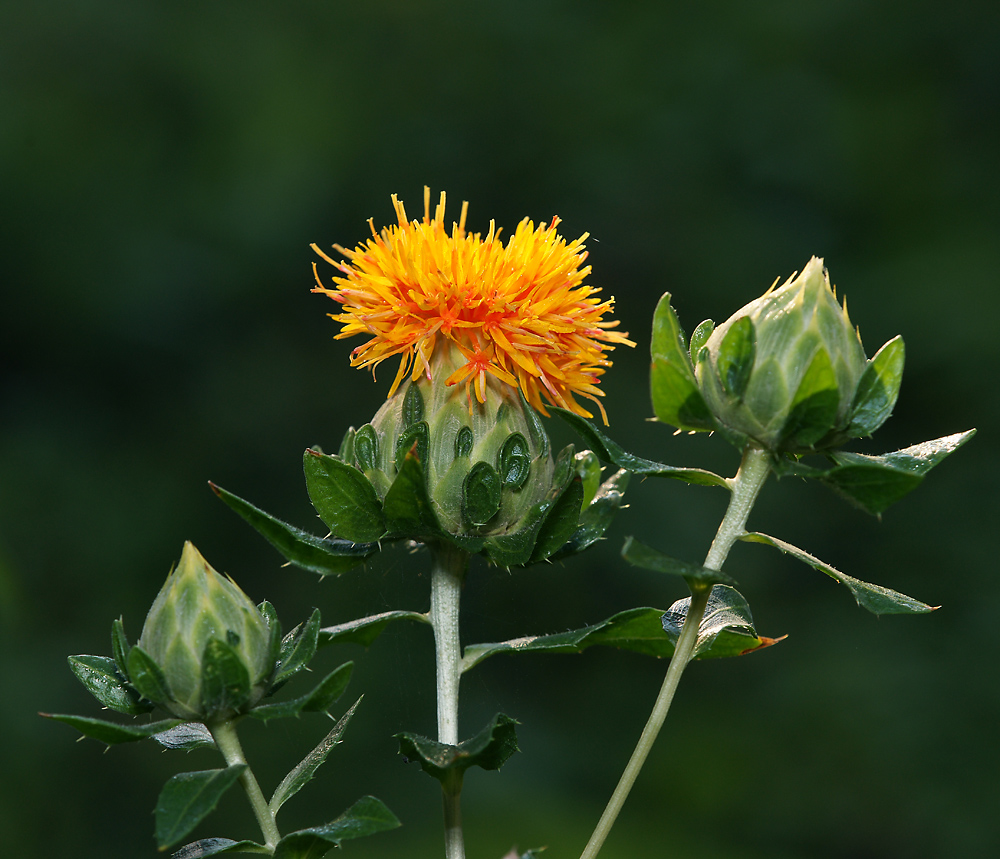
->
xmin=209 ymin=483 xmax=378 ymax=576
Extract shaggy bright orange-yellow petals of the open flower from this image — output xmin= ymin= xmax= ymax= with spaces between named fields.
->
xmin=312 ymin=187 xmax=635 ymax=423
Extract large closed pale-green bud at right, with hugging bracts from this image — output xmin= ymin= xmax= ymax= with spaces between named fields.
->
xmin=691 ymin=257 xmax=903 ymax=454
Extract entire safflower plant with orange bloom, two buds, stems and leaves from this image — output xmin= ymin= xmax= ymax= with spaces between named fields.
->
xmin=47 ymin=188 xmax=974 ymax=859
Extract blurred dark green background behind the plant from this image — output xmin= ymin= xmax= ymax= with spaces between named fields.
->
xmin=0 ymin=0 xmax=1000 ymax=859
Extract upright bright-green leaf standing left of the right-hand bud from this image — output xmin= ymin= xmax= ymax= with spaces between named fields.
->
xmin=648 ymin=292 xmax=715 ymax=430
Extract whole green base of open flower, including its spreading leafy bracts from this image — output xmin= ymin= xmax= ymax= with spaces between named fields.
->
xmin=218 ymin=340 xmax=629 ymax=575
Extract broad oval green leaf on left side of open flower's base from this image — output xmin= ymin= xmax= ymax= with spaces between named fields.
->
xmin=302 ymin=450 xmax=385 ymax=543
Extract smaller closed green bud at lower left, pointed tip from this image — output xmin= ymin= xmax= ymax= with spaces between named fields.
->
xmin=136 ymin=543 xmax=275 ymax=720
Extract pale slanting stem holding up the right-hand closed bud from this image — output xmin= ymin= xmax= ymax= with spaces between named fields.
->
xmin=580 ymin=447 xmax=771 ymax=859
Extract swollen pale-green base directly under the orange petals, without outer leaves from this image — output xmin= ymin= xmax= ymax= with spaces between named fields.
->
xmin=352 ymin=347 xmax=554 ymax=537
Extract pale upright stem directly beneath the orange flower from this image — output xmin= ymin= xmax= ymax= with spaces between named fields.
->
xmin=430 ymin=545 xmax=469 ymax=859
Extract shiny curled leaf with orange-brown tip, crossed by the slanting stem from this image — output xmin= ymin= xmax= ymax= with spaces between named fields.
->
xmin=662 ymin=585 xmax=780 ymax=659
